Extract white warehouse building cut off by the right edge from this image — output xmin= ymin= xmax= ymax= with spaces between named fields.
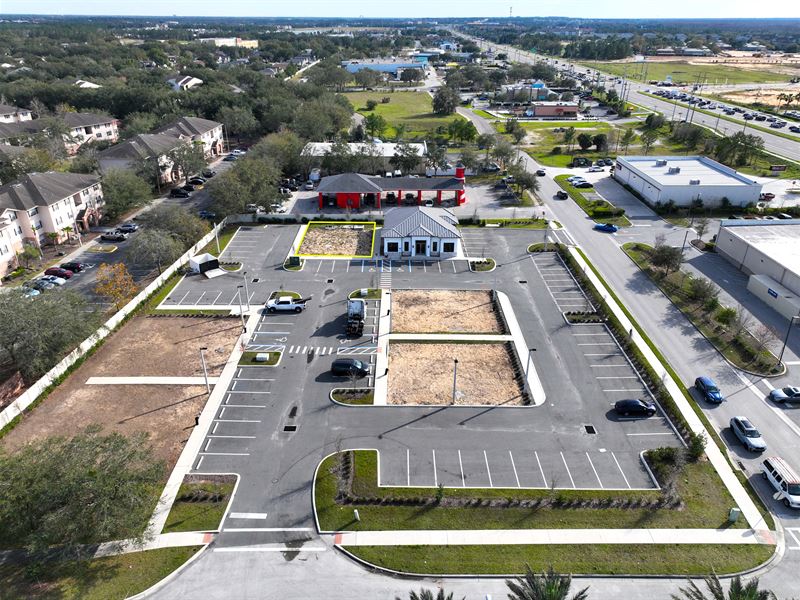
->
xmin=716 ymin=219 xmax=800 ymax=319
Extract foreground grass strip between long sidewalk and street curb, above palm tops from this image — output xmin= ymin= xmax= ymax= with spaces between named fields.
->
xmin=346 ymin=544 xmax=775 ymax=576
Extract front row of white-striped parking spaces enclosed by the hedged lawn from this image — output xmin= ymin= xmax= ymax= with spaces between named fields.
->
xmin=380 ymin=447 xmax=654 ymax=490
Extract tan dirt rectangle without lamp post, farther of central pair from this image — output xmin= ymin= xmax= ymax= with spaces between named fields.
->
xmin=392 ymin=290 xmax=504 ymax=333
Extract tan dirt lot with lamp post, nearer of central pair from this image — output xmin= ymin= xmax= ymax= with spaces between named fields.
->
xmin=387 ymin=342 xmax=523 ymax=406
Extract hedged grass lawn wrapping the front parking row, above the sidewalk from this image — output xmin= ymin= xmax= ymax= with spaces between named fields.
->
xmin=315 ymin=450 xmax=746 ymax=531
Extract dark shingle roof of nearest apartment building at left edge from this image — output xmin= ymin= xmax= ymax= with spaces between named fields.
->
xmin=0 ymin=171 xmax=100 ymax=210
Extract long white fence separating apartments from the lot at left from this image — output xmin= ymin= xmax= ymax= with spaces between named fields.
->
xmin=0 ymin=220 xmax=225 ymax=430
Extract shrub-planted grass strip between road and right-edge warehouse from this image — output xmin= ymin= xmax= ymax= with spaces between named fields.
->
xmin=622 ymin=243 xmax=778 ymax=375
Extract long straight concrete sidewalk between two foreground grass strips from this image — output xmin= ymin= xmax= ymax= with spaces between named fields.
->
xmin=334 ymin=529 xmax=775 ymax=546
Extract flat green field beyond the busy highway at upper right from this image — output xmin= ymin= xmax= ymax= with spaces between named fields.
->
xmin=580 ymin=57 xmax=800 ymax=85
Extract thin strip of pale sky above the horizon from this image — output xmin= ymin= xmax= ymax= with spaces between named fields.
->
xmin=0 ymin=0 xmax=800 ymax=19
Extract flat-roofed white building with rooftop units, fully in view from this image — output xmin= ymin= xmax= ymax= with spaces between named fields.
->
xmin=614 ymin=156 xmax=761 ymax=207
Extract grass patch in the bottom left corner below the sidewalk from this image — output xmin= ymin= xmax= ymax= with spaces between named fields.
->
xmin=0 ymin=546 xmax=200 ymax=600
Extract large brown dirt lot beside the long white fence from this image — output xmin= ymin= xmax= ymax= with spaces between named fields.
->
xmin=0 ymin=316 xmax=241 ymax=468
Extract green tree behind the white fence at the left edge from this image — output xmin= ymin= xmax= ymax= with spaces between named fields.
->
xmin=0 ymin=288 xmax=99 ymax=382
